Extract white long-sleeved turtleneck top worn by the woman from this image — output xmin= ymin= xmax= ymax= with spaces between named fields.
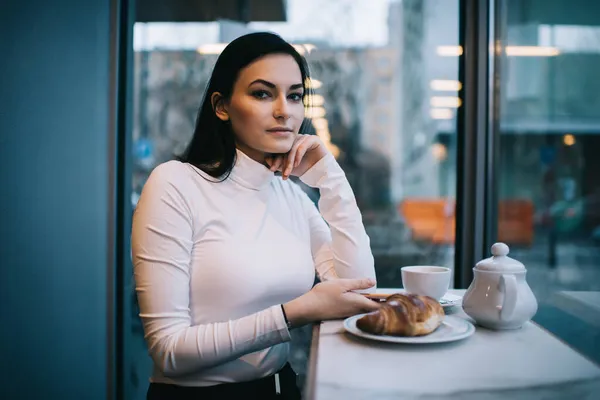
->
xmin=131 ymin=151 xmax=375 ymax=386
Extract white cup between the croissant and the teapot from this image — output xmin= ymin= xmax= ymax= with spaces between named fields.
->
xmin=401 ymin=265 xmax=451 ymax=301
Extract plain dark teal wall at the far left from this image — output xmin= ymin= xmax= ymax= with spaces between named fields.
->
xmin=0 ymin=0 xmax=114 ymax=400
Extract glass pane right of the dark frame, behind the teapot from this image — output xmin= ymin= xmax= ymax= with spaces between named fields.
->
xmin=498 ymin=0 xmax=600 ymax=362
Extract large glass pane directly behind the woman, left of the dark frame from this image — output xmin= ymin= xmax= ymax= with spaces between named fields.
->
xmin=129 ymin=0 xmax=462 ymax=398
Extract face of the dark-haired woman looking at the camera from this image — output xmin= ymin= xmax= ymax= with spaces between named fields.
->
xmin=216 ymin=54 xmax=304 ymax=163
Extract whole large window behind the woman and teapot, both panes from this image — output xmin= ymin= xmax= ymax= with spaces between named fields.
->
xmin=124 ymin=0 xmax=600 ymax=399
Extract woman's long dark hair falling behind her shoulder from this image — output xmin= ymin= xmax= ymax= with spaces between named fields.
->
xmin=178 ymin=32 xmax=310 ymax=180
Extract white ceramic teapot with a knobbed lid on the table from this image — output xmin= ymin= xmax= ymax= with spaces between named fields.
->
xmin=462 ymin=243 xmax=538 ymax=329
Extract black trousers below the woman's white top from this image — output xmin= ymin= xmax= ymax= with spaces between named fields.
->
xmin=146 ymin=363 xmax=301 ymax=400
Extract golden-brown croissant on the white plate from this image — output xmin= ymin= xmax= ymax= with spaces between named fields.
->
xmin=356 ymin=293 xmax=444 ymax=336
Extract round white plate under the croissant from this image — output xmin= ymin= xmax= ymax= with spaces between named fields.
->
xmin=344 ymin=314 xmax=475 ymax=344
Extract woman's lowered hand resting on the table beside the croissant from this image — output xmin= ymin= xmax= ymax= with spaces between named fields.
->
xmin=283 ymin=279 xmax=381 ymax=327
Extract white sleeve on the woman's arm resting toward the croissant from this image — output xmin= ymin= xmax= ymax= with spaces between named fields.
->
xmin=131 ymin=165 xmax=290 ymax=377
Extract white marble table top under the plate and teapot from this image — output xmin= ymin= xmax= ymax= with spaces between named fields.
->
xmin=305 ymin=289 xmax=600 ymax=400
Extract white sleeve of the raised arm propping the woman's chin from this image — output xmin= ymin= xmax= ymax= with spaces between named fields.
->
xmin=300 ymin=154 xmax=375 ymax=288
